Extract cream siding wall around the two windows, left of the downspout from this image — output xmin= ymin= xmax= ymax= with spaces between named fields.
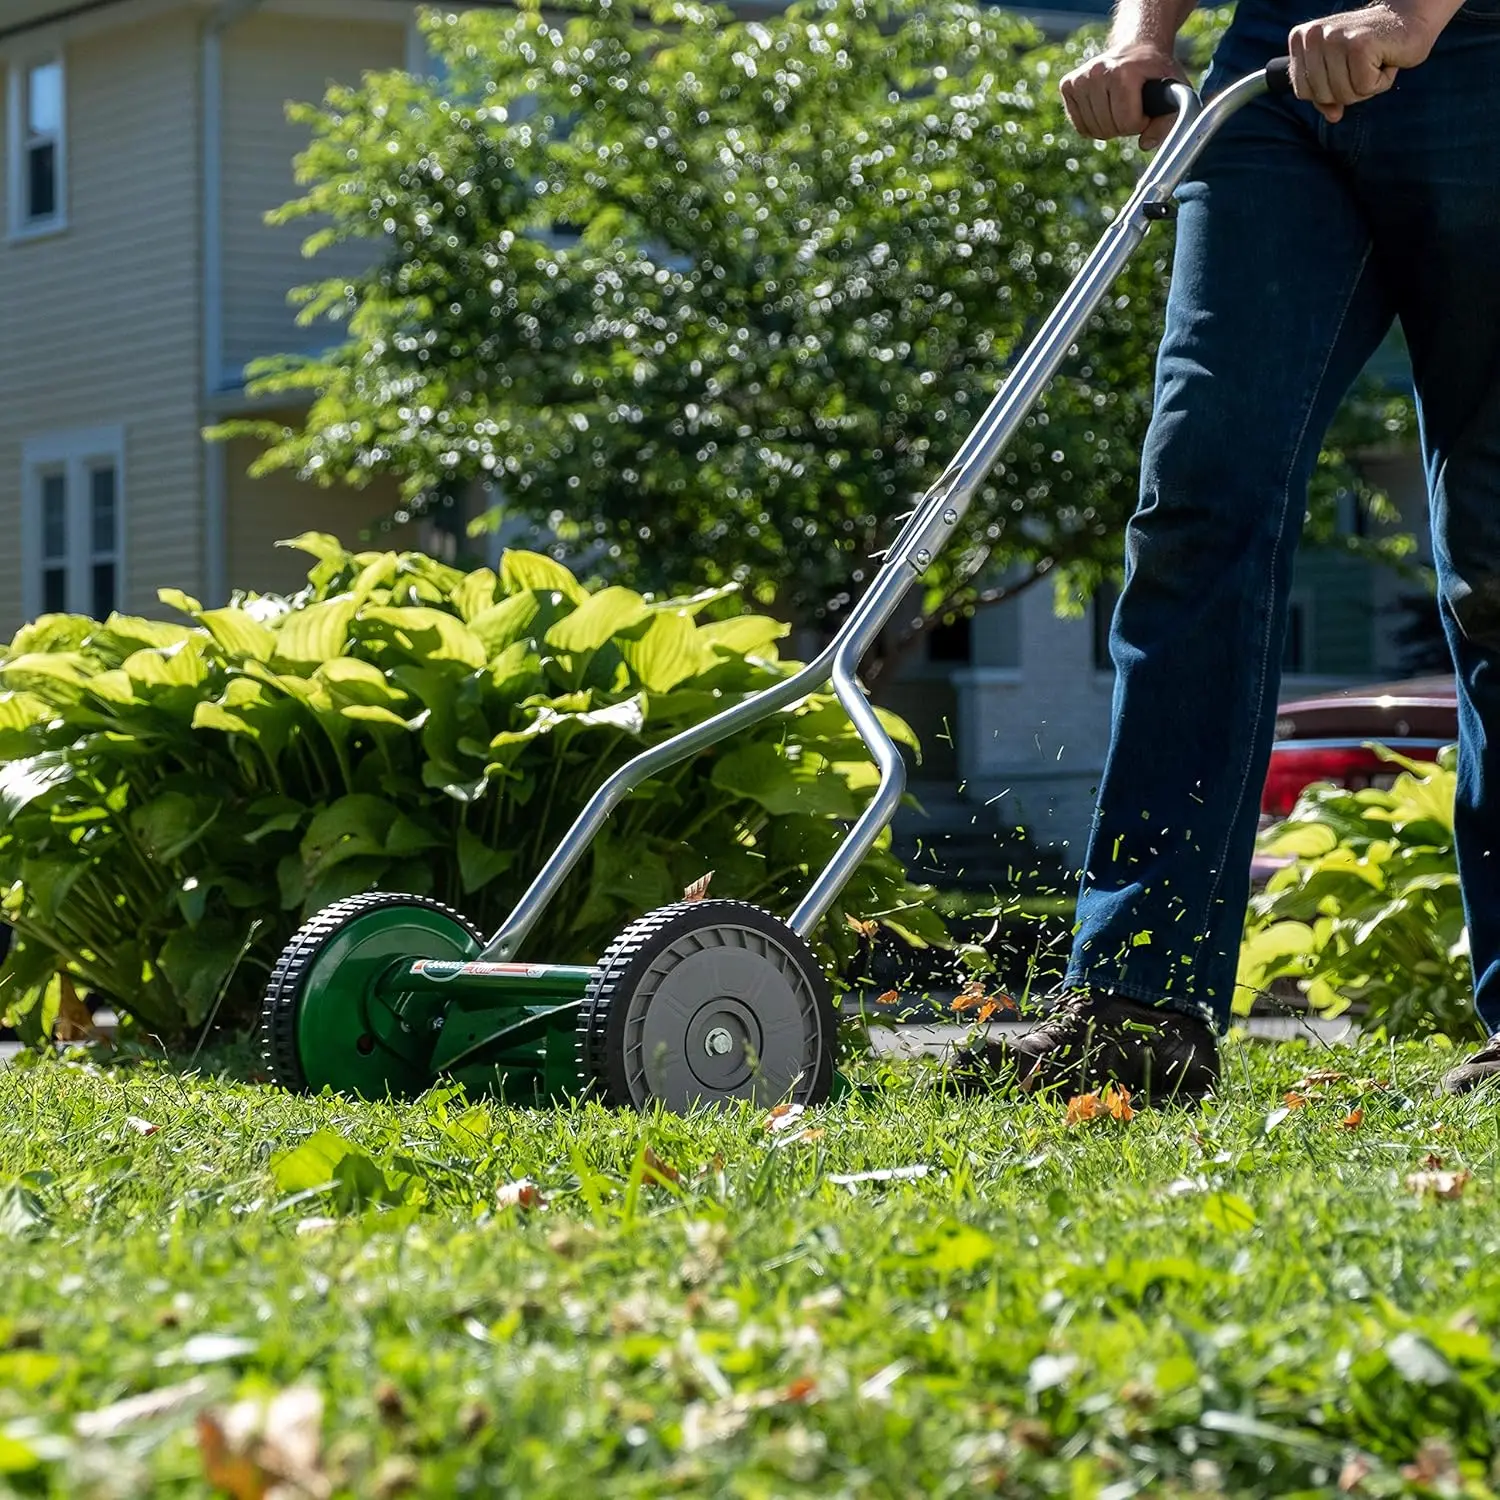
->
xmin=0 ymin=11 xmax=203 ymax=633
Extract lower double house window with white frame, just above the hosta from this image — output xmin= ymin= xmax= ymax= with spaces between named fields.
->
xmin=21 ymin=428 xmax=125 ymax=620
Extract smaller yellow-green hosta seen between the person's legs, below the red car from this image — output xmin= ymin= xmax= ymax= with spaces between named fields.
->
xmin=1236 ymin=747 xmax=1479 ymax=1038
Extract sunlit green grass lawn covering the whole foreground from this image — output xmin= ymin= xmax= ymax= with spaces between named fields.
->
xmin=0 ymin=1043 xmax=1500 ymax=1497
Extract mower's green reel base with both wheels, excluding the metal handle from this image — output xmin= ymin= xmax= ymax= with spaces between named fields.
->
xmin=261 ymin=894 xmax=834 ymax=1109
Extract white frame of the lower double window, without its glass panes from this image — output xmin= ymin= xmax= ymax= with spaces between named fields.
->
xmin=21 ymin=428 xmax=126 ymax=620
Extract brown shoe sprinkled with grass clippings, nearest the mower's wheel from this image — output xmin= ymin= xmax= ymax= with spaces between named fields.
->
xmin=950 ymin=992 xmax=1218 ymax=1104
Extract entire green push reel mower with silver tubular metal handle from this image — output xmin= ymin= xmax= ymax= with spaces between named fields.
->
xmin=261 ymin=59 xmax=1290 ymax=1110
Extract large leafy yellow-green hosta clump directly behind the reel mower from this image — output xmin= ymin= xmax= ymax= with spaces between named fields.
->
xmin=0 ymin=536 xmax=941 ymax=1040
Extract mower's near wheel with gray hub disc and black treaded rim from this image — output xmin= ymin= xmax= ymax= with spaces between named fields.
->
xmin=578 ymin=902 xmax=836 ymax=1110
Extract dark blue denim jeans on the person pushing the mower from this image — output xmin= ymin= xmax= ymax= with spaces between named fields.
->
xmin=1064 ymin=0 xmax=1500 ymax=1031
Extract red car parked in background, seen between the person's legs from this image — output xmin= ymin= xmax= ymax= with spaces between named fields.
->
xmin=1254 ymin=675 xmax=1458 ymax=884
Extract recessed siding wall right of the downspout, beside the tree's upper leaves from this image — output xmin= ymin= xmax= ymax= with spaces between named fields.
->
xmin=216 ymin=8 xmax=407 ymax=381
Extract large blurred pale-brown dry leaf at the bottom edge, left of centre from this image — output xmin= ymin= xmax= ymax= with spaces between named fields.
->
xmin=198 ymin=1386 xmax=332 ymax=1500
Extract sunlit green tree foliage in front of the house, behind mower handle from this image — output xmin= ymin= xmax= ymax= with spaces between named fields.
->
xmin=222 ymin=0 xmax=1416 ymax=654
